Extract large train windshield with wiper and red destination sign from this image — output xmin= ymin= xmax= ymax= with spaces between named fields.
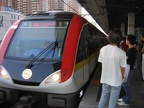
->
xmin=6 ymin=20 xmax=69 ymax=60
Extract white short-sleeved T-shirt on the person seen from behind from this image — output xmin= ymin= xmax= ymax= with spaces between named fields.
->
xmin=98 ymin=45 xmax=127 ymax=86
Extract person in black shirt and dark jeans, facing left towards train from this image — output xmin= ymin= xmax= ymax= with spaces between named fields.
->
xmin=118 ymin=34 xmax=137 ymax=105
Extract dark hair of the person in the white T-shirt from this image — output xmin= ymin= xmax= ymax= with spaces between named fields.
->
xmin=109 ymin=29 xmax=122 ymax=46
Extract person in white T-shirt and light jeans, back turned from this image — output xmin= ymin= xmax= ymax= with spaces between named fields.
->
xmin=98 ymin=29 xmax=127 ymax=108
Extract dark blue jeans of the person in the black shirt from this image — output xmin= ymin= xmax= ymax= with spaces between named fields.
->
xmin=122 ymin=70 xmax=134 ymax=104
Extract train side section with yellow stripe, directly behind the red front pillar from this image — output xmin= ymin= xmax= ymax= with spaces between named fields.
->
xmin=74 ymin=26 xmax=89 ymax=87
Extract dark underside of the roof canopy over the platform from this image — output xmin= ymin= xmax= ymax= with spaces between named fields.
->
xmin=77 ymin=0 xmax=144 ymax=32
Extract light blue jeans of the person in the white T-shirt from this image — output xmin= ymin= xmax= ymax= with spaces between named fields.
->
xmin=98 ymin=84 xmax=121 ymax=108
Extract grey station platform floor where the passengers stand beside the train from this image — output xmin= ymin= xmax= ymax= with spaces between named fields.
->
xmin=78 ymin=55 xmax=144 ymax=108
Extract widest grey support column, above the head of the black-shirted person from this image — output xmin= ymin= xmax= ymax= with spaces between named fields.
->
xmin=127 ymin=13 xmax=135 ymax=34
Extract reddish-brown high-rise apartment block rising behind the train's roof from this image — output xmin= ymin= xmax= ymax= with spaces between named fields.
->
xmin=0 ymin=0 xmax=81 ymax=15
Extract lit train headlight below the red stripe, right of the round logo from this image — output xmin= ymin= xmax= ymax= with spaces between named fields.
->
xmin=45 ymin=71 xmax=61 ymax=84
